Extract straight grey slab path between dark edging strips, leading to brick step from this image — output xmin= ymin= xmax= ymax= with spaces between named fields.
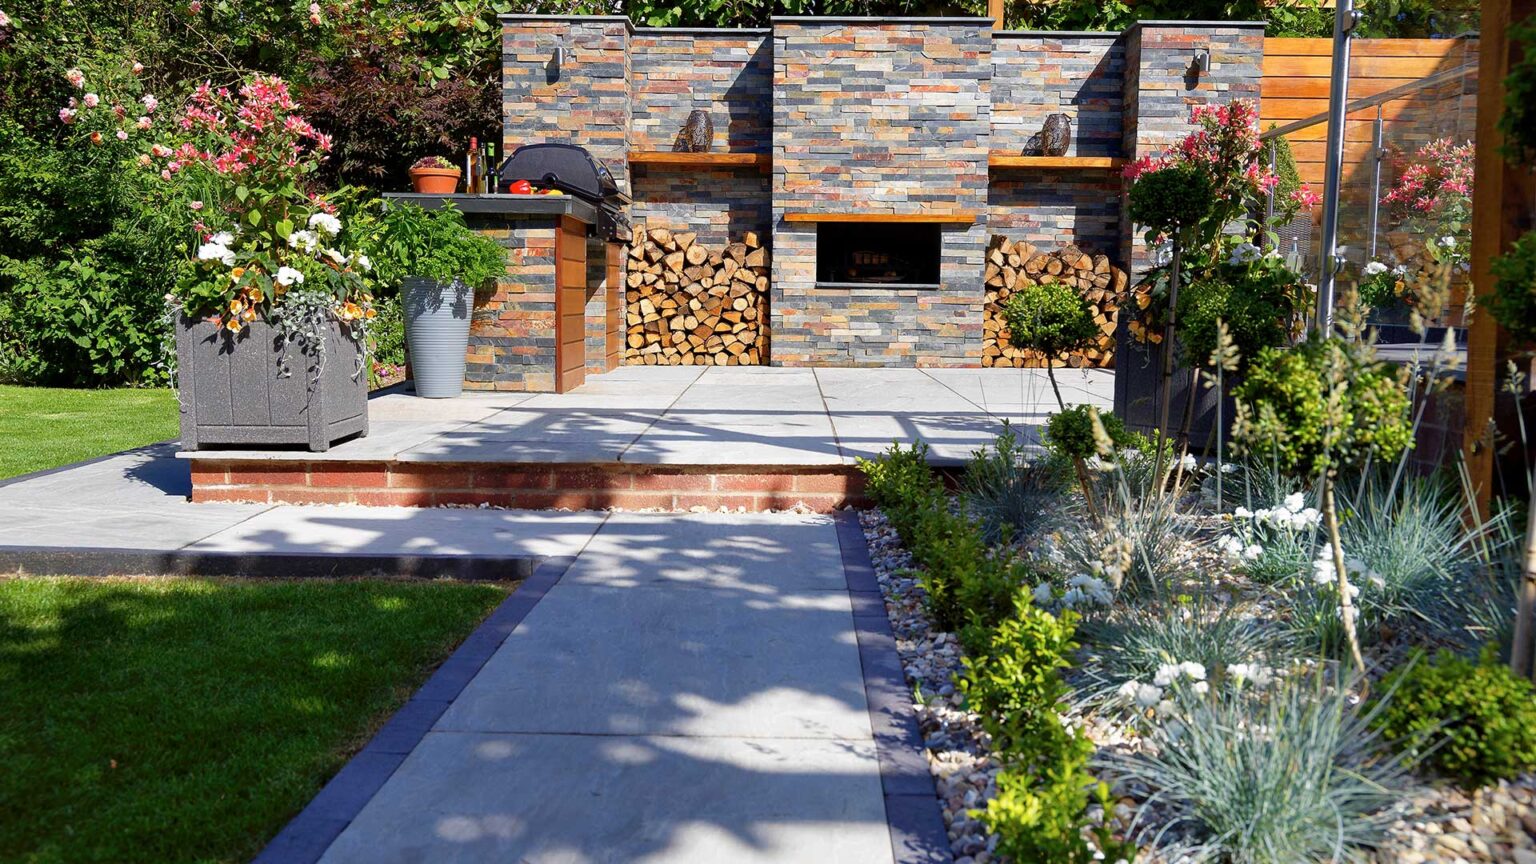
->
xmin=323 ymin=513 xmax=903 ymax=864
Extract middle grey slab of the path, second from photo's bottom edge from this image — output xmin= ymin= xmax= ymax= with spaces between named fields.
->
xmin=436 ymin=584 xmax=869 ymax=731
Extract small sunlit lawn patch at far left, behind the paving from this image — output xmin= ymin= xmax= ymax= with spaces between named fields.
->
xmin=0 ymin=384 xmax=180 ymax=480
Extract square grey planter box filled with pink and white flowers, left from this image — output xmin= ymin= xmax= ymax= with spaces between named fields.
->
xmin=138 ymin=75 xmax=375 ymax=450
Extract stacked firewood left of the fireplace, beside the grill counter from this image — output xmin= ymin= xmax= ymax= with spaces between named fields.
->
xmin=625 ymin=228 xmax=768 ymax=366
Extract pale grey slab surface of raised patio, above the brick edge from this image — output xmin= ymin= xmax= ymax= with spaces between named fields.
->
xmin=185 ymin=366 xmax=1114 ymax=466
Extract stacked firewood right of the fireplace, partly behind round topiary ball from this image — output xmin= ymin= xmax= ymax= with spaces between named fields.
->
xmin=982 ymin=235 xmax=1126 ymax=367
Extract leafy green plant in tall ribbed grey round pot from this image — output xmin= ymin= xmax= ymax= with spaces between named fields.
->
xmin=373 ymin=203 xmax=507 ymax=398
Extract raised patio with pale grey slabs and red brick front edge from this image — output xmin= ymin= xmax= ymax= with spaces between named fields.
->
xmin=181 ymin=366 xmax=1114 ymax=512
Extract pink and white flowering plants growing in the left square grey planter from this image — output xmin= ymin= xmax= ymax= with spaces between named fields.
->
xmin=144 ymin=75 xmax=375 ymax=341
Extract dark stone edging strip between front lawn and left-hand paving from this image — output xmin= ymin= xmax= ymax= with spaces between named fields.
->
xmin=0 ymin=546 xmax=544 ymax=581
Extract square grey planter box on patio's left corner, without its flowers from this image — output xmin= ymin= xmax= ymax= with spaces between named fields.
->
xmin=177 ymin=315 xmax=369 ymax=450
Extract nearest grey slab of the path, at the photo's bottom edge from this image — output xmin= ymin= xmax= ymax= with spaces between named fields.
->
xmin=321 ymin=732 xmax=891 ymax=864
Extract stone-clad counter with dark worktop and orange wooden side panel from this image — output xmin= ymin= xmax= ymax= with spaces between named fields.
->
xmin=386 ymin=194 xmax=624 ymax=392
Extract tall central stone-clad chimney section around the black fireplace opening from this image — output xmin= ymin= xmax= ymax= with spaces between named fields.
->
xmin=773 ymin=18 xmax=992 ymax=366
